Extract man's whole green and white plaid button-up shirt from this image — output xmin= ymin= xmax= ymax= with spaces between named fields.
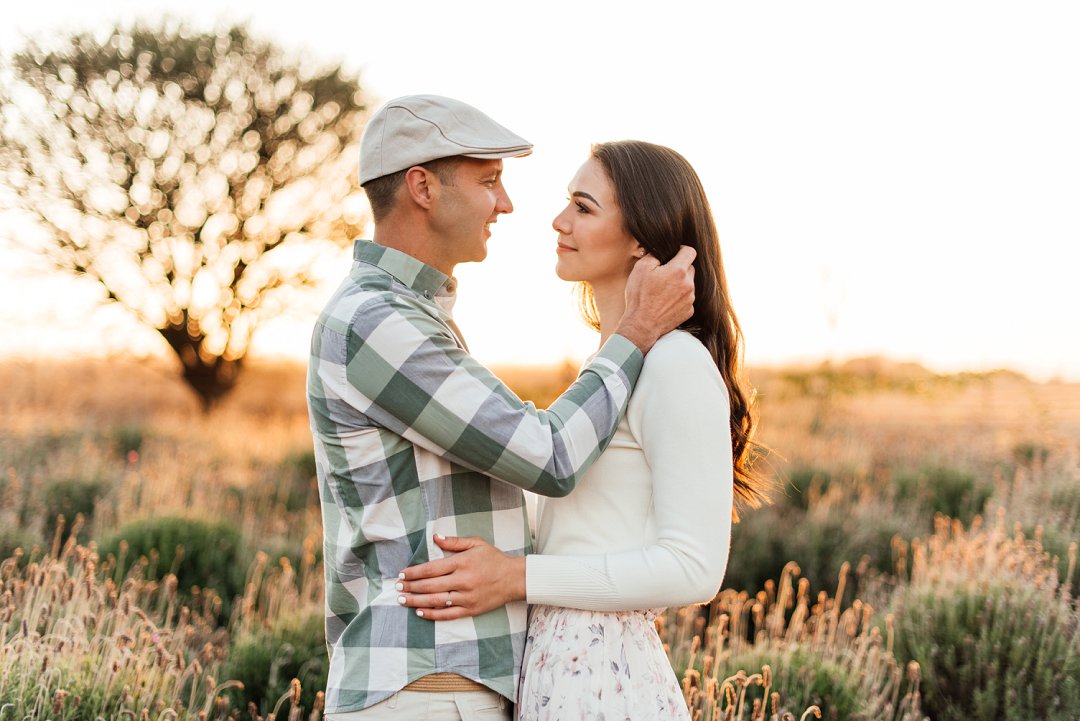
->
xmin=308 ymin=241 xmax=643 ymax=713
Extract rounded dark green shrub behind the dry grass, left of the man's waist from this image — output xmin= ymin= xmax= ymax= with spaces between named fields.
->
xmin=100 ymin=517 xmax=253 ymax=617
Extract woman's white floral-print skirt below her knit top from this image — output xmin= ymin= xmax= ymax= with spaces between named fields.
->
xmin=517 ymin=606 xmax=690 ymax=721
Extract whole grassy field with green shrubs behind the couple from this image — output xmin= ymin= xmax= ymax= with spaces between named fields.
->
xmin=0 ymin=359 xmax=1080 ymax=721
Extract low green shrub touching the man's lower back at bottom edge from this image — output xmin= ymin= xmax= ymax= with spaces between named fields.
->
xmin=222 ymin=613 xmax=329 ymax=715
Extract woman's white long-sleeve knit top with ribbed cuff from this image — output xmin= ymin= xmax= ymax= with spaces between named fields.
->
xmin=525 ymin=330 xmax=733 ymax=611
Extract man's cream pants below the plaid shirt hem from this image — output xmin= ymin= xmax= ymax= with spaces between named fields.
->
xmin=326 ymin=691 xmax=512 ymax=721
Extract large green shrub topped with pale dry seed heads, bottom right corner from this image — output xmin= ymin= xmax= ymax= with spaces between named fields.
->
xmin=893 ymin=520 xmax=1080 ymax=721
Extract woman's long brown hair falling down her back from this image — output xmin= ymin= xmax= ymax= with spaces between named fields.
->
xmin=581 ymin=140 xmax=770 ymax=520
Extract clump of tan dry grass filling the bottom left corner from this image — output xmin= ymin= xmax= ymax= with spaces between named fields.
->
xmin=0 ymin=533 xmax=228 ymax=719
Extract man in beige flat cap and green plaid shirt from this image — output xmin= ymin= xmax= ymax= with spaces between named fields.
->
xmin=308 ymin=95 xmax=693 ymax=719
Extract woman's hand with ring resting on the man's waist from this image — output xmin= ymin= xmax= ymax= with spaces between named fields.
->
xmin=397 ymin=533 xmax=525 ymax=621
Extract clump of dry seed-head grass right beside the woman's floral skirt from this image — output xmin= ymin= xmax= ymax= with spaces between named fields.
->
xmin=660 ymin=563 xmax=922 ymax=721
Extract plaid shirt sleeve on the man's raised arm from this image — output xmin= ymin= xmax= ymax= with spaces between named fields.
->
xmin=316 ymin=296 xmax=642 ymax=496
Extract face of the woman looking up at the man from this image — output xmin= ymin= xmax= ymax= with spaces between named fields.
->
xmin=551 ymin=158 xmax=640 ymax=286
